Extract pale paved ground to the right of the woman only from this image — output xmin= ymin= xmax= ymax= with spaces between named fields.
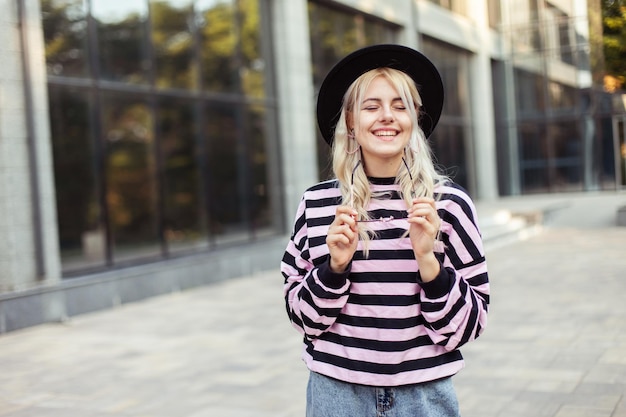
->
xmin=455 ymin=193 xmax=626 ymax=417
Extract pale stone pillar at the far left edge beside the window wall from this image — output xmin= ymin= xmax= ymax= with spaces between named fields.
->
xmin=0 ymin=0 xmax=60 ymax=292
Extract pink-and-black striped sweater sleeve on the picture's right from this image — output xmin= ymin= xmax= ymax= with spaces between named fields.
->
xmin=421 ymin=187 xmax=489 ymax=350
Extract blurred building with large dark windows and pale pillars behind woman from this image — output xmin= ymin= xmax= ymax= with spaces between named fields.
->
xmin=0 ymin=0 xmax=626 ymax=333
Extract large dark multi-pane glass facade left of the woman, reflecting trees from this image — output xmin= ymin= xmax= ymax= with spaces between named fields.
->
xmin=41 ymin=0 xmax=282 ymax=275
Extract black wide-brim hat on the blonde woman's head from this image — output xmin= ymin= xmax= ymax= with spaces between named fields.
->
xmin=317 ymin=44 xmax=444 ymax=145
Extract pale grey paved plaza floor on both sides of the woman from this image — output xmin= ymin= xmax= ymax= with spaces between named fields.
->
xmin=0 ymin=193 xmax=626 ymax=417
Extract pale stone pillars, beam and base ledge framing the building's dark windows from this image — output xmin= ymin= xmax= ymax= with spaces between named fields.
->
xmin=0 ymin=0 xmax=604 ymax=333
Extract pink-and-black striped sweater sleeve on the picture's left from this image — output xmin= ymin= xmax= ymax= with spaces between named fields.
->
xmin=280 ymin=193 xmax=350 ymax=340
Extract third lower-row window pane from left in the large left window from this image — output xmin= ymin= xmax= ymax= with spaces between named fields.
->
xmin=158 ymin=98 xmax=208 ymax=251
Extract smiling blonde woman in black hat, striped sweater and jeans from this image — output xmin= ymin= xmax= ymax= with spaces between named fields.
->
xmin=281 ymin=45 xmax=489 ymax=417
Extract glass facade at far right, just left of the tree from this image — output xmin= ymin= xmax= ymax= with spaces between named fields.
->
xmin=494 ymin=0 xmax=615 ymax=194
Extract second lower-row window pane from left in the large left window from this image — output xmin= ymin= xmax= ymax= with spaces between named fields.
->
xmin=102 ymin=93 xmax=160 ymax=262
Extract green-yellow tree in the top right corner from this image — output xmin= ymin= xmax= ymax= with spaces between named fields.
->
xmin=602 ymin=0 xmax=626 ymax=90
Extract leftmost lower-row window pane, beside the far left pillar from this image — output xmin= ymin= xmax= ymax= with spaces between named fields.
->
xmin=49 ymin=87 xmax=106 ymax=271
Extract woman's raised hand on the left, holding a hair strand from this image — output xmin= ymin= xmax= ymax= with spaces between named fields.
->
xmin=326 ymin=206 xmax=359 ymax=273
